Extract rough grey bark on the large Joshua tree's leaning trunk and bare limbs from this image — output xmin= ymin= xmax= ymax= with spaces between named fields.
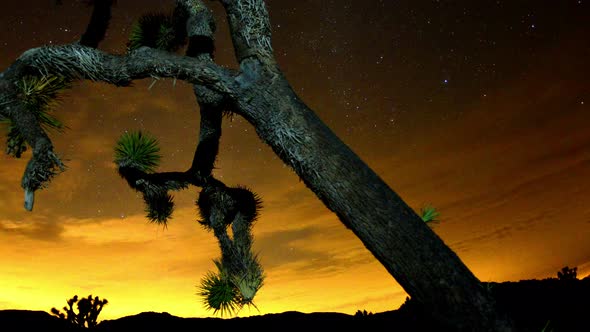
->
xmin=0 ymin=0 xmax=514 ymax=331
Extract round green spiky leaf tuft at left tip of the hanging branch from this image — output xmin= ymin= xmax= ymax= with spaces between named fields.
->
xmin=114 ymin=131 xmax=161 ymax=173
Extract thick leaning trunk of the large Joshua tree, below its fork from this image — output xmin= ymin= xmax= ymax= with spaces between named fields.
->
xmin=229 ymin=58 xmax=512 ymax=331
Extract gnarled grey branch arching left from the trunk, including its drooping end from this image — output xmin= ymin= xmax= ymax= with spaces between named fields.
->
xmin=0 ymin=40 xmax=236 ymax=210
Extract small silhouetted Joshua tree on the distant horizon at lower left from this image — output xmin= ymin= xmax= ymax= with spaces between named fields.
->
xmin=51 ymin=295 xmax=109 ymax=328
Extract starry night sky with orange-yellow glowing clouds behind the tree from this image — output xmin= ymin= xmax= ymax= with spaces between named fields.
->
xmin=0 ymin=0 xmax=590 ymax=319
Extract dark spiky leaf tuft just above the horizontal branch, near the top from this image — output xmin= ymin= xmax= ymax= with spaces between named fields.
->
xmin=127 ymin=13 xmax=186 ymax=52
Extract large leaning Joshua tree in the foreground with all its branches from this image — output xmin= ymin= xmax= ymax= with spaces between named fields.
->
xmin=0 ymin=0 xmax=513 ymax=332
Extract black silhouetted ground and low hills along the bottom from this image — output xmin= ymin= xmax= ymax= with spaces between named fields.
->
xmin=0 ymin=277 xmax=590 ymax=332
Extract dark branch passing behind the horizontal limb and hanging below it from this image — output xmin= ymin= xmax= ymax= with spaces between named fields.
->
xmin=111 ymin=1 xmax=259 ymax=228
